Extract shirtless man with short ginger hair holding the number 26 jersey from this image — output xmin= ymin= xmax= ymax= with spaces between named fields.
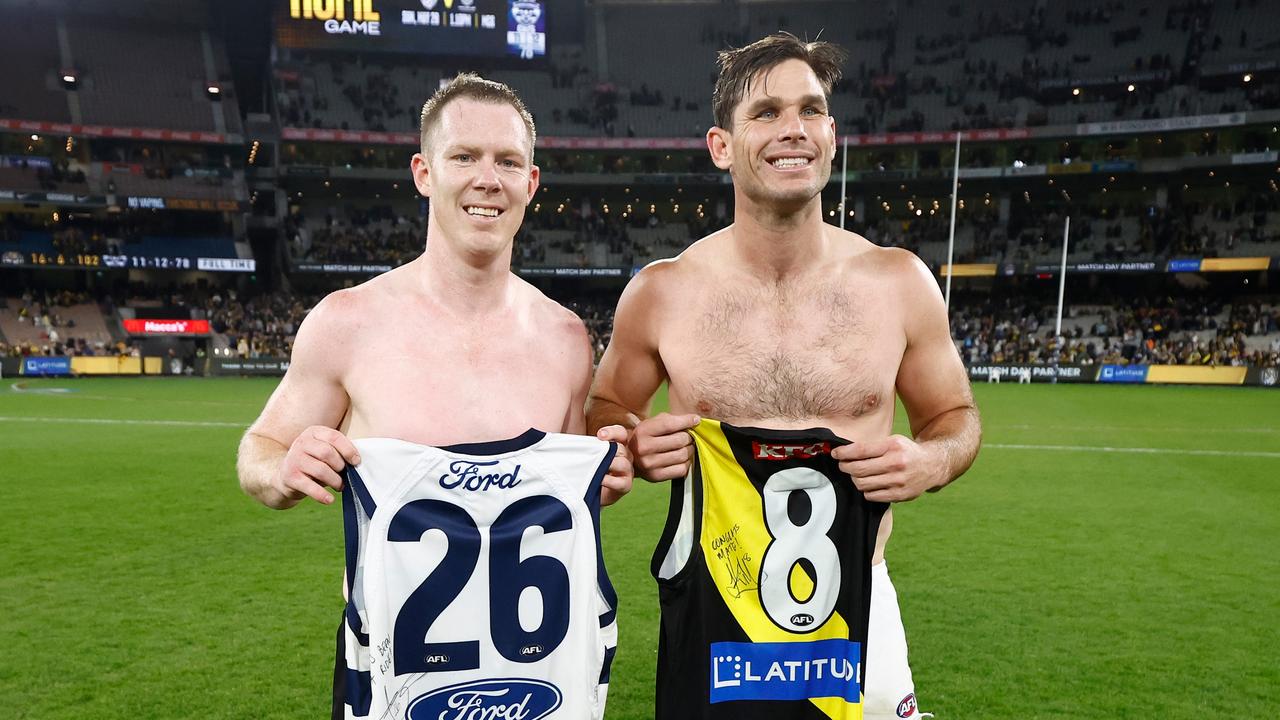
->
xmin=237 ymin=74 xmax=631 ymax=717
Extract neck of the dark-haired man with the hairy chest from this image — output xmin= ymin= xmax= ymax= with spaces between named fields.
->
xmin=733 ymin=197 xmax=827 ymax=282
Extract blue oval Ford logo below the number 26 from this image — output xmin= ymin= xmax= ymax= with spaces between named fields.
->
xmin=404 ymin=678 xmax=561 ymax=720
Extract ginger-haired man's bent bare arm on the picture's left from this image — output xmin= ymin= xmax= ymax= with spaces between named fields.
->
xmin=236 ymin=296 xmax=348 ymax=510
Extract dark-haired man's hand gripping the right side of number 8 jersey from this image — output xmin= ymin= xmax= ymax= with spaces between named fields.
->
xmin=831 ymin=436 xmax=942 ymax=502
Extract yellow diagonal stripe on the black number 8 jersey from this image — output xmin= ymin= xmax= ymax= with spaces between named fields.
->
xmin=691 ymin=418 xmax=863 ymax=720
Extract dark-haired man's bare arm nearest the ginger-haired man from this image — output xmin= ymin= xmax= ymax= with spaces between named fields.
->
xmin=586 ymin=264 xmax=671 ymax=432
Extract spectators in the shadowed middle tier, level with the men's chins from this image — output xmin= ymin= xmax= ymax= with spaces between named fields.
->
xmin=285 ymin=192 xmax=1280 ymax=266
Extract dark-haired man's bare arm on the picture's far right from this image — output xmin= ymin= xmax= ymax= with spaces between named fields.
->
xmin=896 ymin=249 xmax=982 ymax=491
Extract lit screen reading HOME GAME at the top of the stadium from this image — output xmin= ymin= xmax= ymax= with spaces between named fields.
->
xmin=275 ymin=0 xmax=547 ymax=61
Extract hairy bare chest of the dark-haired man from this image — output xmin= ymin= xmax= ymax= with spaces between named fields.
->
xmin=662 ymin=287 xmax=904 ymax=420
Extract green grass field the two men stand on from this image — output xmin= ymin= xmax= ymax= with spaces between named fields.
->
xmin=0 ymin=378 xmax=1280 ymax=720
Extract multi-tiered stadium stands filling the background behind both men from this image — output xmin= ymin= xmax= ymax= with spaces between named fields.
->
xmin=0 ymin=0 xmax=1280 ymax=376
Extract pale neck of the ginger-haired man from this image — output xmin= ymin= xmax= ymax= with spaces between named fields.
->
xmin=416 ymin=233 xmax=515 ymax=316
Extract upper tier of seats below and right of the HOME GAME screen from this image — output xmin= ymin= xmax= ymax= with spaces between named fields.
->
xmin=267 ymin=0 xmax=1277 ymax=137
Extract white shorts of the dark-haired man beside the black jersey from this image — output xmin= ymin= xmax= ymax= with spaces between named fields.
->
xmin=863 ymin=562 xmax=920 ymax=720
